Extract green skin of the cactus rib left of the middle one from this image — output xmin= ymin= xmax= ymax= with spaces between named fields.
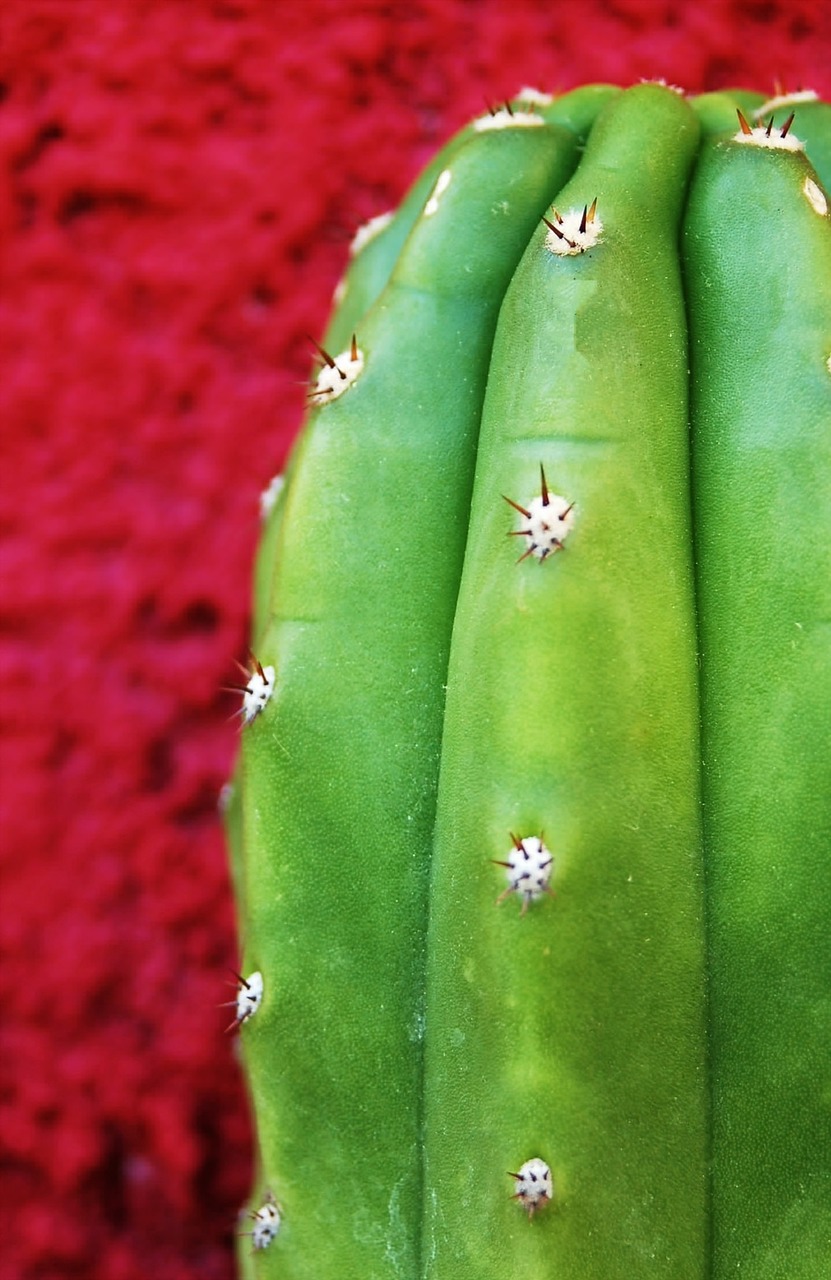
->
xmin=236 ymin=115 xmax=576 ymax=1280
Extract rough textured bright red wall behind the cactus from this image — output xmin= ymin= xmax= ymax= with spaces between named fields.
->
xmin=0 ymin=0 xmax=831 ymax=1280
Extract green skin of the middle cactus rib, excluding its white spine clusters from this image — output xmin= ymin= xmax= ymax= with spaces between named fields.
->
xmin=425 ymin=86 xmax=708 ymax=1280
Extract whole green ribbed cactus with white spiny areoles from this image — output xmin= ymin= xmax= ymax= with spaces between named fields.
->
xmin=229 ymin=84 xmax=831 ymax=1280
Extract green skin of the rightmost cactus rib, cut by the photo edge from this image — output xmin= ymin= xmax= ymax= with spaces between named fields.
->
xmin=684 ymin=124 xmax=831 ymax=1280
